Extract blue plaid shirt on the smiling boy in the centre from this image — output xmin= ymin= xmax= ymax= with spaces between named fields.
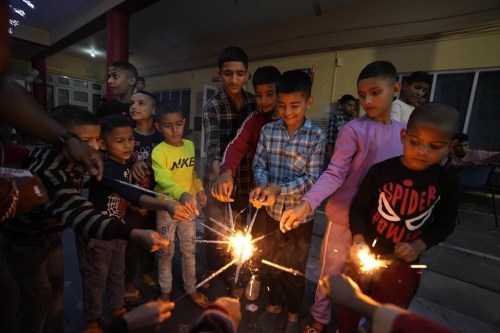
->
xmin=253 ymin=118 xmax=325 ymax=223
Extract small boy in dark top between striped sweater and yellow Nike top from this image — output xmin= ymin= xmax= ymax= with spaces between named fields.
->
xmin=79 ymin=116 xmax=193 ymax=330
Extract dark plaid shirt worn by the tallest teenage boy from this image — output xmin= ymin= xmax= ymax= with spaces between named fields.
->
xmin=203 ymin=88 xmax=257 ymax=196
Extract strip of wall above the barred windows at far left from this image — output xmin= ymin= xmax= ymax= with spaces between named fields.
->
xmin=46 ymin=53 xmax=106 ymax=82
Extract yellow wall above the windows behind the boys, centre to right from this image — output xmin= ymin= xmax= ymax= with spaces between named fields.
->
xmin=146 ymin=32 xmax=500 ymax=124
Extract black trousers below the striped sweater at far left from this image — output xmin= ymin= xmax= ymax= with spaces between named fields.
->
xmin=2 ymin=233 xmax=64 ymax=333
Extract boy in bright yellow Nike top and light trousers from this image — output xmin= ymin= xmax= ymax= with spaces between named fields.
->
xmin=151 ymin=102 xmax=208 ymax=307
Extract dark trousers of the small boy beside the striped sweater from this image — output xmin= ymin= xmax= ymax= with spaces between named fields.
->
xmin=80 ymin=238 xmax=127 ymax=321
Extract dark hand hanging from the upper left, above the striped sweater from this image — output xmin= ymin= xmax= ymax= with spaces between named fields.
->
xmin=63 ymin=138 xmax=104 ymax=180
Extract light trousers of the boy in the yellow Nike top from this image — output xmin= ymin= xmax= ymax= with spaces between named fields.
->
xmin=156 ymin=210 xmax=196 ymax=294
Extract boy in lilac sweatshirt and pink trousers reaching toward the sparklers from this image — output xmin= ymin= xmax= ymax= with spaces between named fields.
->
xmin=280 ymin=61 xmax=403 ymax=333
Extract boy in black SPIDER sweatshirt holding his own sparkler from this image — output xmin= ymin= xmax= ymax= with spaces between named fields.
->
xmin=339 ymin=103 xmax=459 ymax=333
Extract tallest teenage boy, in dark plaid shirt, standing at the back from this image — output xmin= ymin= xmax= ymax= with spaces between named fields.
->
xmin=203 ymin=46 xmax=257 ymax=296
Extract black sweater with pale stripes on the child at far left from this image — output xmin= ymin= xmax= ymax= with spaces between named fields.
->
xmin=0 ymin=147 xmax=131 ymax=240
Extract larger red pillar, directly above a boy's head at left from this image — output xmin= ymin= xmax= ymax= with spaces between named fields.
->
xmin=106 ymin=10 xmax=129 ymax=100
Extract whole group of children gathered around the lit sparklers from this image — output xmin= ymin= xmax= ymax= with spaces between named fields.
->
xmin=1 ymin=47 xmax=458 ymax=333
